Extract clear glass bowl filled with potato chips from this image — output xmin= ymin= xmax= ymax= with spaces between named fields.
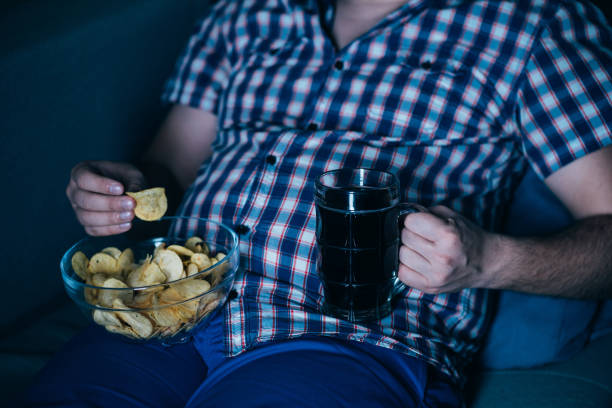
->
xmin=60 ymin=217 xmax=240 ymax=345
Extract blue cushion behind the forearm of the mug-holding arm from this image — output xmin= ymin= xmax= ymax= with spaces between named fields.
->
xmin=479 ymin=171 xmax=609 ymax=369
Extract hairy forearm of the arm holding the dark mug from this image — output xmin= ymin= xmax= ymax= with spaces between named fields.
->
xmin=485 ymin=215 xmax=612 ymax=298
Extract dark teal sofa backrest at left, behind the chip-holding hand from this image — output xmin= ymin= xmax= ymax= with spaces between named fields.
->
xmin=0 ymin=0 xmax=206 ymax=333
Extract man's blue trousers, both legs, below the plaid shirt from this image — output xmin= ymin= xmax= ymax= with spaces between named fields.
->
xmin=24 ymin=319 xmax=462 ymax=408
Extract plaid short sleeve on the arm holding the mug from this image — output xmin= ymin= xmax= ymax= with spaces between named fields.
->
xmin=517 ymin=1 xmax=612 ymax=178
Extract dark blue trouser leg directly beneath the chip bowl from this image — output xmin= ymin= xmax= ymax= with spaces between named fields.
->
xmin=20 ymin=326 xmax=206 ymax=408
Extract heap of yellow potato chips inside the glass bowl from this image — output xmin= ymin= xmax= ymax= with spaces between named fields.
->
xmin=83 ymin=236 xmax=229 ymax=339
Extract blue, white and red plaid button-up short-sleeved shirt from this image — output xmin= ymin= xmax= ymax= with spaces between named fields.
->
xmin=163 ymin=0 xmax=612 ymax=381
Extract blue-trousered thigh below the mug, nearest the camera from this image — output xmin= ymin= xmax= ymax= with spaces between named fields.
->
xmin=187 ymin=338 xmax=461 ymax=408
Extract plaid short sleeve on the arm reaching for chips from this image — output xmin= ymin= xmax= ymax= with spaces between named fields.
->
xmin=162 ymin=1 xmax=230 ymax=114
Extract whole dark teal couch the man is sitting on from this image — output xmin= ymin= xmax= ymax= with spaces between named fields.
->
xmin=0 ymin=0 xmax=612 ymax=408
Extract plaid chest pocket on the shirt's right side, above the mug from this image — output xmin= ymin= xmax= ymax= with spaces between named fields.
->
xmin=363 ymin=58 xmax=486 ymax=147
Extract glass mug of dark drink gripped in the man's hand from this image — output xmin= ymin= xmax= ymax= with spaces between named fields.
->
xmin=315 ymin=168 xmax=418 ymax=322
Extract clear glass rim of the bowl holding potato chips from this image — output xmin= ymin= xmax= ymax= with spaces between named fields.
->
xmin=60 ymin=215 xmax=239 ymax=292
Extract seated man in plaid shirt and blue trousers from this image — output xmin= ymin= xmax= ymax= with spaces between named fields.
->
xmin=31 ymin=0 xmax=612 ymax=407
